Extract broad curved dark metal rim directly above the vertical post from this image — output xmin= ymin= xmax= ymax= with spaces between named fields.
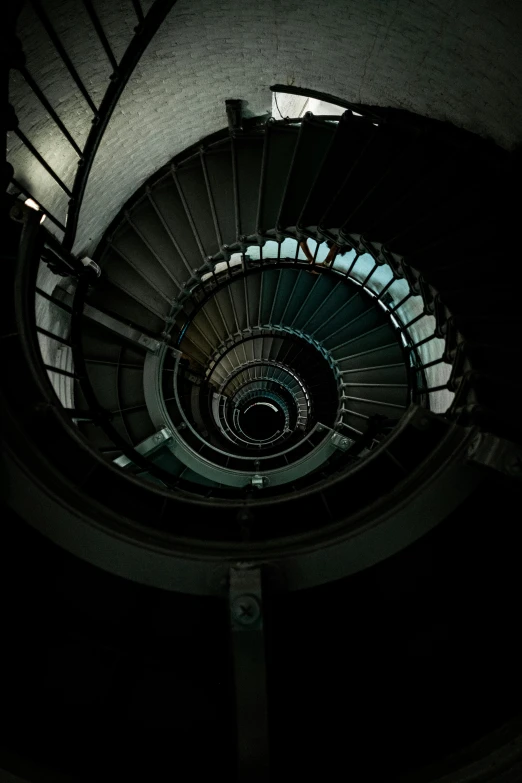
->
xmin=6 ymin=384 xmax=481 ymax=596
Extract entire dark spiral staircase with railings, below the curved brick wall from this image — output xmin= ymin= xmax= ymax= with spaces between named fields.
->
xmin=2 ymin=2 xmax=522 ymax=783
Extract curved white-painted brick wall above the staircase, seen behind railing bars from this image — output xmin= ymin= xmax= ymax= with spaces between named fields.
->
xmin=10 ymin=0 xmax=522 ymax=251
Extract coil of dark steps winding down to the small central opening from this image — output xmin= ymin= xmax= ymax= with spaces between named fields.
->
xmin=43 ymin=111 xmax=484 ymax=497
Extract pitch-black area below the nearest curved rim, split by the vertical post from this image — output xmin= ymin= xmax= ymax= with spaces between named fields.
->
xmin=0 ymin=474 xmax=522 ymax=783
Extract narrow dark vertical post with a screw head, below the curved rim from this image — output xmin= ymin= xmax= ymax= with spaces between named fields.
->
xmin=229 ymin=563 xmax=269 ymax=783
